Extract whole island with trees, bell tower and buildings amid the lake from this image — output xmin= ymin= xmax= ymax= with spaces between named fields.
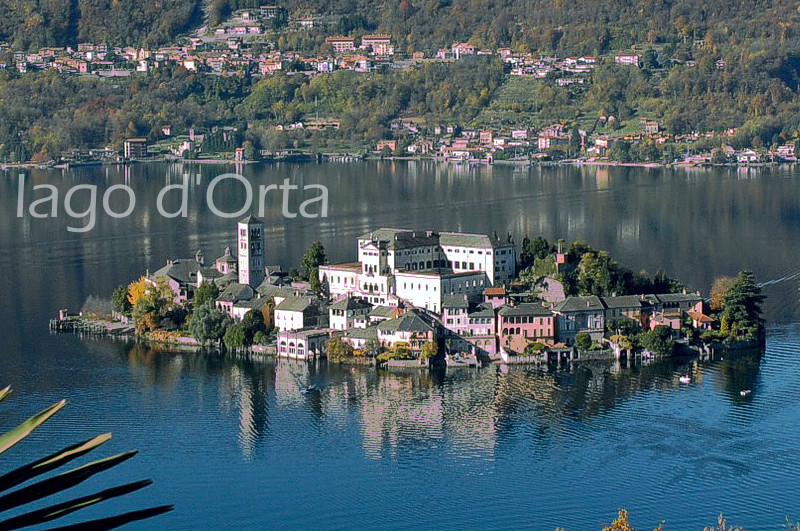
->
xmin=50 ymin=216 xmax=764 ymax=368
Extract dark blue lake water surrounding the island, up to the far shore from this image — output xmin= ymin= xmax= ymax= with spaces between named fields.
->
xmin=0 ymin=162 xmax=800 ymax=530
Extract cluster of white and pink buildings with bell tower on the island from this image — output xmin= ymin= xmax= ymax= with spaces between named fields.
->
xmin=139 ymin=217 xmax=713 ymax=364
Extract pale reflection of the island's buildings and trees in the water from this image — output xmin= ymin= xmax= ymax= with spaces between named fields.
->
xmin=120 ymin=345 xmax=762 ymax=459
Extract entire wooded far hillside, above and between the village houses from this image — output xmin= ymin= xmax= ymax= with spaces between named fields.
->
xmin=0 ymin=0 xmax=800 ymax=161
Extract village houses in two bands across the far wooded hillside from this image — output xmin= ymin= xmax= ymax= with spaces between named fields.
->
xmin=0 ymin=5 xmax=797 ymax=165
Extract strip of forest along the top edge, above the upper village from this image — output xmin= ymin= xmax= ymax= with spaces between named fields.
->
xmin=0 ymin=0 xmax=800 ymax=53
